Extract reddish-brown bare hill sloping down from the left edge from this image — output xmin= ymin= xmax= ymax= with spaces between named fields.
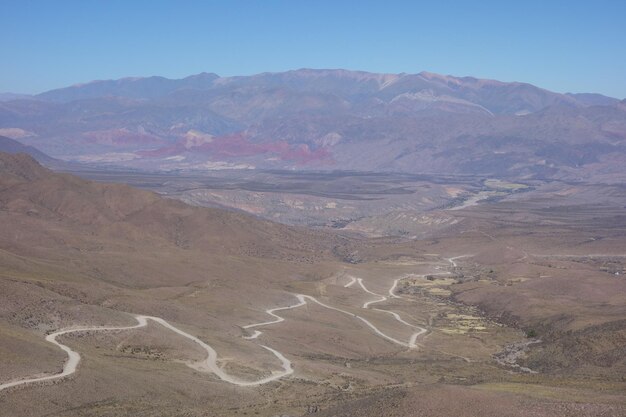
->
xmin=0 ymin=153 xmax=346 ymax=261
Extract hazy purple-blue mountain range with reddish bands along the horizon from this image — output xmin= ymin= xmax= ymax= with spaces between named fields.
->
xmin=0 ymin=69 xmax=626 ymax=182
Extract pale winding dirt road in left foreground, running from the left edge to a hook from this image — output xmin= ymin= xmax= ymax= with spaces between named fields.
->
xmin=0 ymin=315 xmax=293 ymax=391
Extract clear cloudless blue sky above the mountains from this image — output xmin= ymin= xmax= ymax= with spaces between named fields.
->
xmin=0 ymin=0 xmax=626 ymax=98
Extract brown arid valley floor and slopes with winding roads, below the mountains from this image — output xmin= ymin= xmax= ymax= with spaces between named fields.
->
xmin=0 ymin=153 xmax=626 ymax=416
